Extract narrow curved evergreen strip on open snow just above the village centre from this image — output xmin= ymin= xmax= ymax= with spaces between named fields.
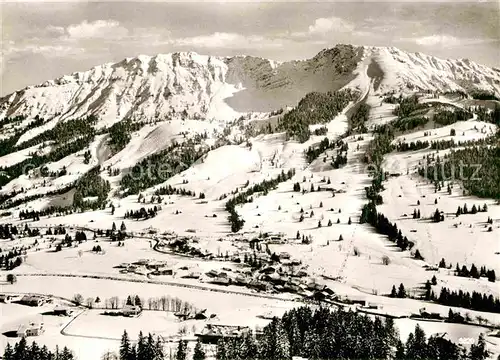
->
xmin=225 ymin=169 xmax=295 ymax=232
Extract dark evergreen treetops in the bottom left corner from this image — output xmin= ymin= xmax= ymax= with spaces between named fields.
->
xmin=2 ymin=338 xmax=75 ymax=360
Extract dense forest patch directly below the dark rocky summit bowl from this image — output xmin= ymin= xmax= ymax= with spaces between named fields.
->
xmin=276 ymin=89 xmax=356 ymax=143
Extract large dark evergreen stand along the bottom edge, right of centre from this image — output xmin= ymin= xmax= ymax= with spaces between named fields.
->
xmin=216 ymin=307 xmax=480 ymax=360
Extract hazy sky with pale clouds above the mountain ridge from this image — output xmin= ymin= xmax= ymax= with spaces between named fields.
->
xmin=0 ymin=0 xmax=500 ymax=95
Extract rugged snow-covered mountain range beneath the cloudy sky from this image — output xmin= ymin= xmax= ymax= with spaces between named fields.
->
xmin=0 ymin=45 xmax=500 ymax=126
